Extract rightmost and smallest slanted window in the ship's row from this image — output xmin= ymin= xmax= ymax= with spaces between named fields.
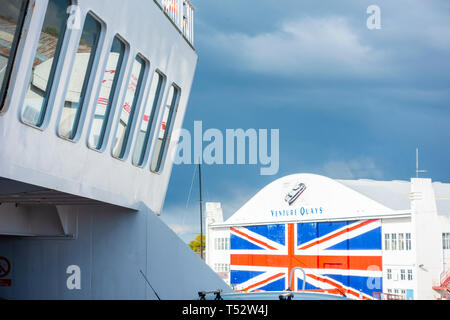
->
xmin=150 ymin=85 xmax=180 ymax=172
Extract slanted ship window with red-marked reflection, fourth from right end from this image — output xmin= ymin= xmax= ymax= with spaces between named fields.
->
xmin=88 ymin=36 xmax=126 ymax=150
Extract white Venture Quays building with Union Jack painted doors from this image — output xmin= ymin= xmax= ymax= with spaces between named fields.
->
xmin=206 ymin=174 xmax=450 ymax=299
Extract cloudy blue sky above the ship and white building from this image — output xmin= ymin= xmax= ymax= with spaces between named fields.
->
xmin=162 ymin=0 xmax=450 ymax=242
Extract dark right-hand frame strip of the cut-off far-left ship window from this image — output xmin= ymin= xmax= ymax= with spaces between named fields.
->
xmin=0 ymin=0 xmax=31 ymax=114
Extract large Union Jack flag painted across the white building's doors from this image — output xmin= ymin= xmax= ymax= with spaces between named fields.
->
xmin=230 ymin=220 xmax=382 ymax=299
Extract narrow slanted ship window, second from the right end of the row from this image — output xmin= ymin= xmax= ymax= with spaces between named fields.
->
xmin=133 ymin=71 xmax=164 ymax=167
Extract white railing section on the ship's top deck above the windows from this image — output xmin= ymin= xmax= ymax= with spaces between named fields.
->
xmin=159 ymin=0 xmax=195 ymax=46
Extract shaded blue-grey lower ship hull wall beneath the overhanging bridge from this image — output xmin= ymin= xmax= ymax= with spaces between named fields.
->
xmin=0 ymin=205 xmax=232 ymax=299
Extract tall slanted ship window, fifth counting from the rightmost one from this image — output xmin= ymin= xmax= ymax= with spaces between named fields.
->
xmin=58 ymin=13 xmax=102 ymax=140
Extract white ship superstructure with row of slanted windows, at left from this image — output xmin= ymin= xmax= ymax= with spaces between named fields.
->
xmin=0 ymin=0 xmax=230 ymax=299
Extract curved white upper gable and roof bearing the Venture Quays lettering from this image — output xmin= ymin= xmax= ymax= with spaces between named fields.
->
xmin=225 ymin=174 xmax=410 ymax=225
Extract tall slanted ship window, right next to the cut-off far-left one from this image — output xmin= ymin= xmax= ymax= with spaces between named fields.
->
xmin=22 ymin=0 xmax=71 ymax=127
